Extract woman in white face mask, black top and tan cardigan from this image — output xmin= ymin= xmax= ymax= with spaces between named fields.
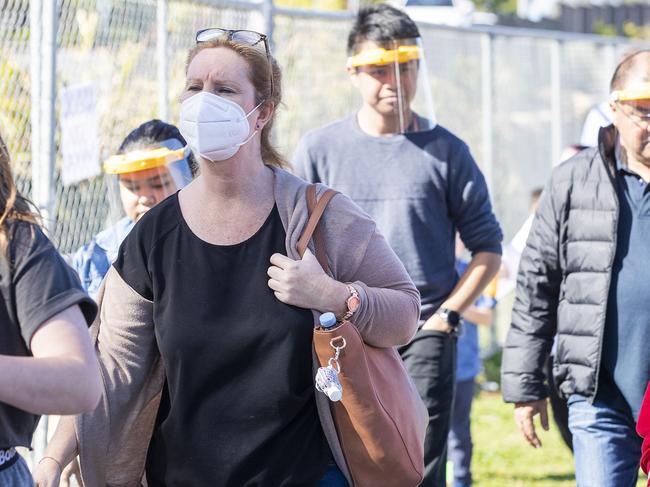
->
xmin=36 ymin=29 xmax=419 ymax=487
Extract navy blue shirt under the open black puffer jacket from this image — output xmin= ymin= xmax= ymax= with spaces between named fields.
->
xmin=599 ymin=157 xmax=650 ymax=418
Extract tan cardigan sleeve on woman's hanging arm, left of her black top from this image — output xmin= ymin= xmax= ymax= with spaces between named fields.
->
xmin=75 ymin=267 xmax=164 ymax=487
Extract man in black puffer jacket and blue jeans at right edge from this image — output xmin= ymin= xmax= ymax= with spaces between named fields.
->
xmin=501 ymin=50 xmax=650 ymax=487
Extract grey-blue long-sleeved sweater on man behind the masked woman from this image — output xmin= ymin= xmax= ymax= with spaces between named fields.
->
xmin=293 ymin=115 xmax=502 ymax=320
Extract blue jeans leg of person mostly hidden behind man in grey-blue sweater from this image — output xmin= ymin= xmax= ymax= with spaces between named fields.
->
xmin=447 ymin=378 xmax=474 ymax=487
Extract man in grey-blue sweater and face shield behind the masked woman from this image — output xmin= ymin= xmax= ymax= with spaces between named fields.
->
xmin=293 ymin=4 xmax=502 ymax=487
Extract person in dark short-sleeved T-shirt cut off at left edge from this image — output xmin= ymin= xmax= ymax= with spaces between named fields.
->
xmin=0 ymin=132 xmax=101 ymax=487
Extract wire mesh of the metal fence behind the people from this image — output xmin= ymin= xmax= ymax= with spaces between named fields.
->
xmin=0 ymin=0 xmax=644 ymax=252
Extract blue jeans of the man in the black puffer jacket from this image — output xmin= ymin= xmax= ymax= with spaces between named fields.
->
xmin=569 ymin=395 xmax=642 ymax=487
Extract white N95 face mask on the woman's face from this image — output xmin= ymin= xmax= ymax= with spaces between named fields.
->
xmin=178 ymin=91 xmax=263 ymax=162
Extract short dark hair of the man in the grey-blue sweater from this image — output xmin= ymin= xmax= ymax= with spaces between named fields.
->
xmin=348 ymin=3 xmax=420 ymax=55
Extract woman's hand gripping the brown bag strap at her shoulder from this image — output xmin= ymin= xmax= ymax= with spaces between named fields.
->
xmin=268 ymin=249 xmax=350 ymax=317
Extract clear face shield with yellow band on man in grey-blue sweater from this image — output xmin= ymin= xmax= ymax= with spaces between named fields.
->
xmin=348 ymin=37 xmax=436 ymax=134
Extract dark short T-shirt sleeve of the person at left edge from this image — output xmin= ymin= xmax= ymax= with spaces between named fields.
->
xmin=9 ymin=222 xmax=97 ymax=349
